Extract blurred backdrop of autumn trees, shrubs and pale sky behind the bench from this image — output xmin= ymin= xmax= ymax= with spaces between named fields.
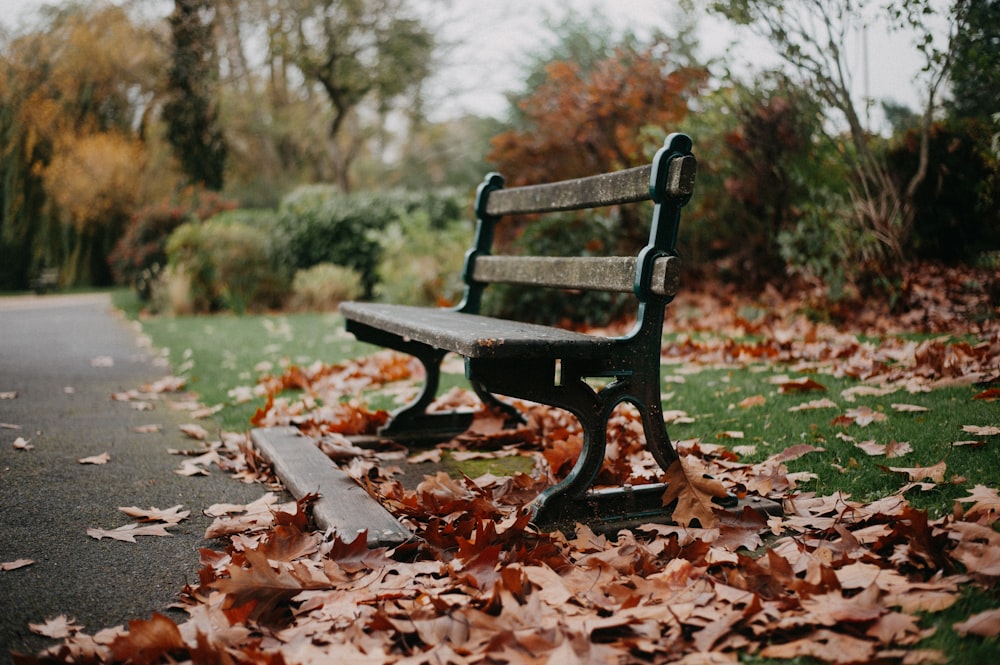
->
xmin=0 ymin=0 xmax=1000 ymax=321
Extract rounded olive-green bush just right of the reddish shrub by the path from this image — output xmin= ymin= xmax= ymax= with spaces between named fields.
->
xmin=167 ymin=220 xmax=288 ymax=313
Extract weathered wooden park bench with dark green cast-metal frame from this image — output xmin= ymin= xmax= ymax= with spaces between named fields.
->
xmin=340 ymin=134 xmax=696 ymax=528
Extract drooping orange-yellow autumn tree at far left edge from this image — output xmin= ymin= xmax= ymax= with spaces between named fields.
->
xmin=0 ymin=3 xmax=170 ymax=288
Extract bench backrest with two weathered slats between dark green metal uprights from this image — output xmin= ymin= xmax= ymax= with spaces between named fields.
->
xmin=458 ymin=134 xmax=697 ymax=315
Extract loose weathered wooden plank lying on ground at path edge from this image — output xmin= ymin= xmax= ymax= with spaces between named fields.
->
xmin=250 ymin=427 xmax=413 ymax=547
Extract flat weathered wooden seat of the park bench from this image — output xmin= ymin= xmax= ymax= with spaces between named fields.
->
xmin=340 ymin=302 xmax=614 ymax=359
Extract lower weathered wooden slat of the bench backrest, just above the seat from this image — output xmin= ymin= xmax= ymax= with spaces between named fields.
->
xmin=472 ymin=256 xmax=680 ymax=296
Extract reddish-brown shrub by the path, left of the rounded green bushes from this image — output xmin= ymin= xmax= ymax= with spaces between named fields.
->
xmin=108 ymin=188 xmax=236 ymax=301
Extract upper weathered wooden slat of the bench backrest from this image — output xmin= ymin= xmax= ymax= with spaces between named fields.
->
xmin=486 ymin=164 xmax=653 ymax=217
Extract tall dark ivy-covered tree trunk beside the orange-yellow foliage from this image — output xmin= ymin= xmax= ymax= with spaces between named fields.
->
xmin=163 ymin=0 xmax=227 ymax=191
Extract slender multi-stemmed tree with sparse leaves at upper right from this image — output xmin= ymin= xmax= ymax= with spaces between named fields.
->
xmin=710 ymin=0 xmax=967 ymax=273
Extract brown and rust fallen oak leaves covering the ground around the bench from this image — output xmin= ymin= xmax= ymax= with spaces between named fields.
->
xmin=15 ymin=268 xmax=1000 ymax=665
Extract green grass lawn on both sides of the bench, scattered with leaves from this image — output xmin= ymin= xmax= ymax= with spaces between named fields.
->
xmin=111 ymin=288 xmax=1000 ymax=665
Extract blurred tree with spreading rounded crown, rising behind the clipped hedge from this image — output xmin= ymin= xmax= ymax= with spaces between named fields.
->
xmin=272 ymin=0 xmax=434 ymax=192
